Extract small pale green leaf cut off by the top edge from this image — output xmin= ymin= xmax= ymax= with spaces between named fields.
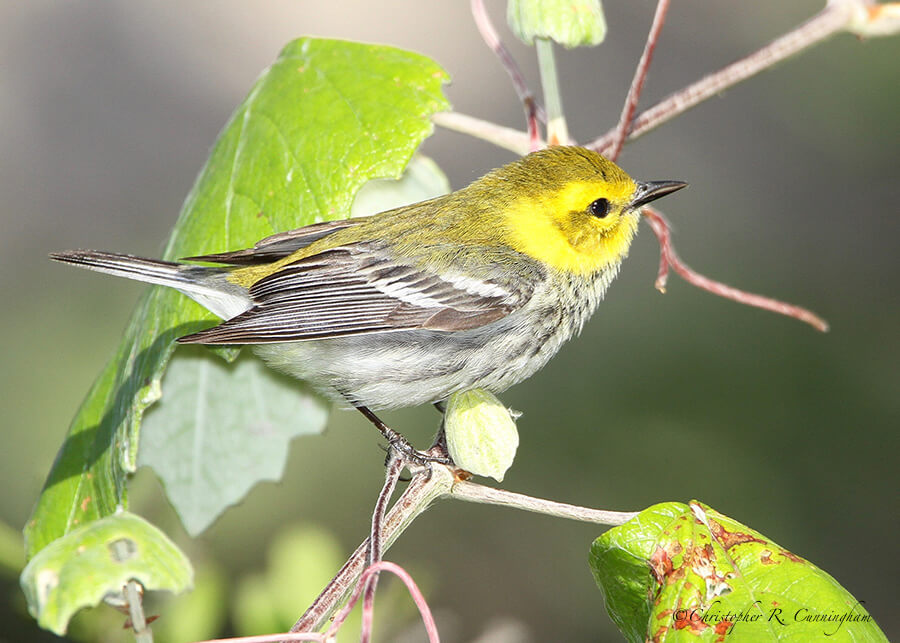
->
xmin=506 ymin=0 xmax=606 ymax=48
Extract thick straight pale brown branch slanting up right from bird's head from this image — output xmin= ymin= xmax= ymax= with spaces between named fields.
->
xmin=585 ymin=1 xmax=856 ymax=154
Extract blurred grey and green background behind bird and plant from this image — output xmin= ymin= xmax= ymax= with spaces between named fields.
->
xmin=0 ymin=0 xmax=900 ymax=641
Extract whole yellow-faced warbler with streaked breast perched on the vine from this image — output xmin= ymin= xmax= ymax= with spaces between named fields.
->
xmin=51 ymin=147 xmax=686 ymax=458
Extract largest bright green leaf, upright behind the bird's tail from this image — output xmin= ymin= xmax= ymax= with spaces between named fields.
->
xmin=25 ymin=38 xmax=448 ymax=557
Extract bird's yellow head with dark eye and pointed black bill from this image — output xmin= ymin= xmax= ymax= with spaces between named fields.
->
xmin=483 ymin=147 xmax=686 ymax=275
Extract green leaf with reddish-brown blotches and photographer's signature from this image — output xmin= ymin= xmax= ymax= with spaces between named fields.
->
xmin=590 ymin=501 xmax=887 ymax=643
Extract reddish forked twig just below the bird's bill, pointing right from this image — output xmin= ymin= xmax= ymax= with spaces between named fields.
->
xmin=643 ymin=206 xmax=828 ymax=333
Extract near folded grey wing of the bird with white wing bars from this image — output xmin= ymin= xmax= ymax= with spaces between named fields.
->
xmin=178 ymin=243 xmax=533 ymax=344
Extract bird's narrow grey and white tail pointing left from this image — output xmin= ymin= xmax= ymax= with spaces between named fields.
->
xmin=50 ymin=250 xmax=252 ymax=319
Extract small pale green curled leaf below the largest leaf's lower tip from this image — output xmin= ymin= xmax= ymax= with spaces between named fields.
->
xmin=20 ymin=512 xmax=193 ymax=636
